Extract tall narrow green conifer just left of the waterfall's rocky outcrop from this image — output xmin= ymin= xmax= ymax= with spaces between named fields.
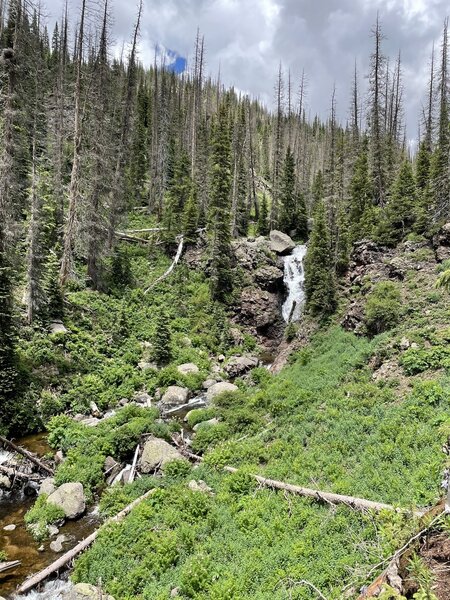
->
xmin=209 ymin=97 xmax=233 ymax=302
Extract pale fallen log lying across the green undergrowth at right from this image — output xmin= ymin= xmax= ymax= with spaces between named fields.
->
xmin=224 ymin=467 xmax=424 ymax=517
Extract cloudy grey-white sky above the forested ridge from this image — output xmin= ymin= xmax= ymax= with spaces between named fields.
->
xmin=46 ymin=0 xmax=450 ymax=138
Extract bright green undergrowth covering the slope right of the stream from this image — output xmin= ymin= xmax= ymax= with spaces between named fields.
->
xmin=70 ymin=327 xmax=450 ymax=600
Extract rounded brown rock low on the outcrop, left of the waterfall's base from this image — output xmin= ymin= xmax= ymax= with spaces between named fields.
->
xmin=239 ymin=287 xmax=281 ymax=328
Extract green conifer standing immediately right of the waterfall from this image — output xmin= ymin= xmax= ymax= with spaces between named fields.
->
xmin=305 ymin=200 xmax=336 ymax=316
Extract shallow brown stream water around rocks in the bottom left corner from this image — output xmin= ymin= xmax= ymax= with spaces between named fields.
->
xmin=0 ymin=434 xmax=99 ymax=600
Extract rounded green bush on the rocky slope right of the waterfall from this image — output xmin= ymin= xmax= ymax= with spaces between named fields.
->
xmin=365 ymin=281 xmax=402 ymax=335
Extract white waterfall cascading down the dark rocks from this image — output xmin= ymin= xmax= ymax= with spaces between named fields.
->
xmin=283 ymin=245 xmax=307 ymax=323
